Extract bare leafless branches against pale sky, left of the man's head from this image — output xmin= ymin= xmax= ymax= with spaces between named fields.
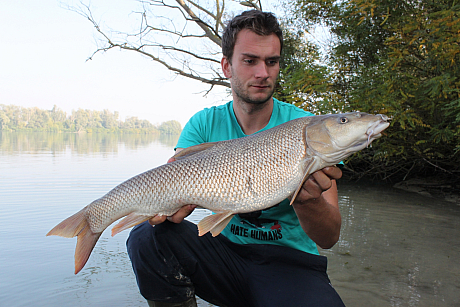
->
xmin=70 ymin=0 xmax=268 ymax=89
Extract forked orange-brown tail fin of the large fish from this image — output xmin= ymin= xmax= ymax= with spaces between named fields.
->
xmin=46 ymin=207 xmax=102 ymax=274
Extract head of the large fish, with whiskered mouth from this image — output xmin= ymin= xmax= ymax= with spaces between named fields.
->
xmin=305 ymin=112 xmax=390 ymax=163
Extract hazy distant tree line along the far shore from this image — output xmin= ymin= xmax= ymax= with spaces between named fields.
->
xmin=0 ymin=104 xmax=182 ymax=135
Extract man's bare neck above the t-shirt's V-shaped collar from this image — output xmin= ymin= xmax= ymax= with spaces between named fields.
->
xmin=233 ymin=98 xmax=273 ymax=135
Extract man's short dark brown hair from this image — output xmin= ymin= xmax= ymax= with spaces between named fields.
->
xmin=222 ymin=10 xmax=283 ymax=63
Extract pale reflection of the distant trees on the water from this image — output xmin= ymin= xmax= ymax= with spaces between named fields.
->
xmin=0 ymin=131 xmax=179 ymax=154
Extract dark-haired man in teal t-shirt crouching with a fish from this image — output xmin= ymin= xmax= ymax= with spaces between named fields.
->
xmin=127 ymin=10 xmax=343 ymax=307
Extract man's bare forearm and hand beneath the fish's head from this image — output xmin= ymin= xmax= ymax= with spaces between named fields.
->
xmin=292 ymin=166 xmax=342 ymax=249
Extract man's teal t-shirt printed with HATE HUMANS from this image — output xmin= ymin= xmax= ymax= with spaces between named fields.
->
xmin=176 ymin=99 xmax=319 ymax=255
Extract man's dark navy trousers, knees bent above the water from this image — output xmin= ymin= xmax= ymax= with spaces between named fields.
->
xmin=127 ymin=221 xmax=344 ymax=307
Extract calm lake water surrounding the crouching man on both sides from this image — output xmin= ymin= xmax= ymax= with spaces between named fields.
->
xmin=0 ymin=133 xmax=460 ymax=307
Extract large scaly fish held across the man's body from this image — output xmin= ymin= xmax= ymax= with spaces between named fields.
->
xmin=47 ymin=112 xmax=389 ymax=274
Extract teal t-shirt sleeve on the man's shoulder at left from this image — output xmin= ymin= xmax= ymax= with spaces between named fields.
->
xmin=174 ymin=111 xmax=206 ymax=150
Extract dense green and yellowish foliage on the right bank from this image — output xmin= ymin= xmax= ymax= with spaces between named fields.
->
xmin=295 ymin=0 xmax=460 ymax=182
